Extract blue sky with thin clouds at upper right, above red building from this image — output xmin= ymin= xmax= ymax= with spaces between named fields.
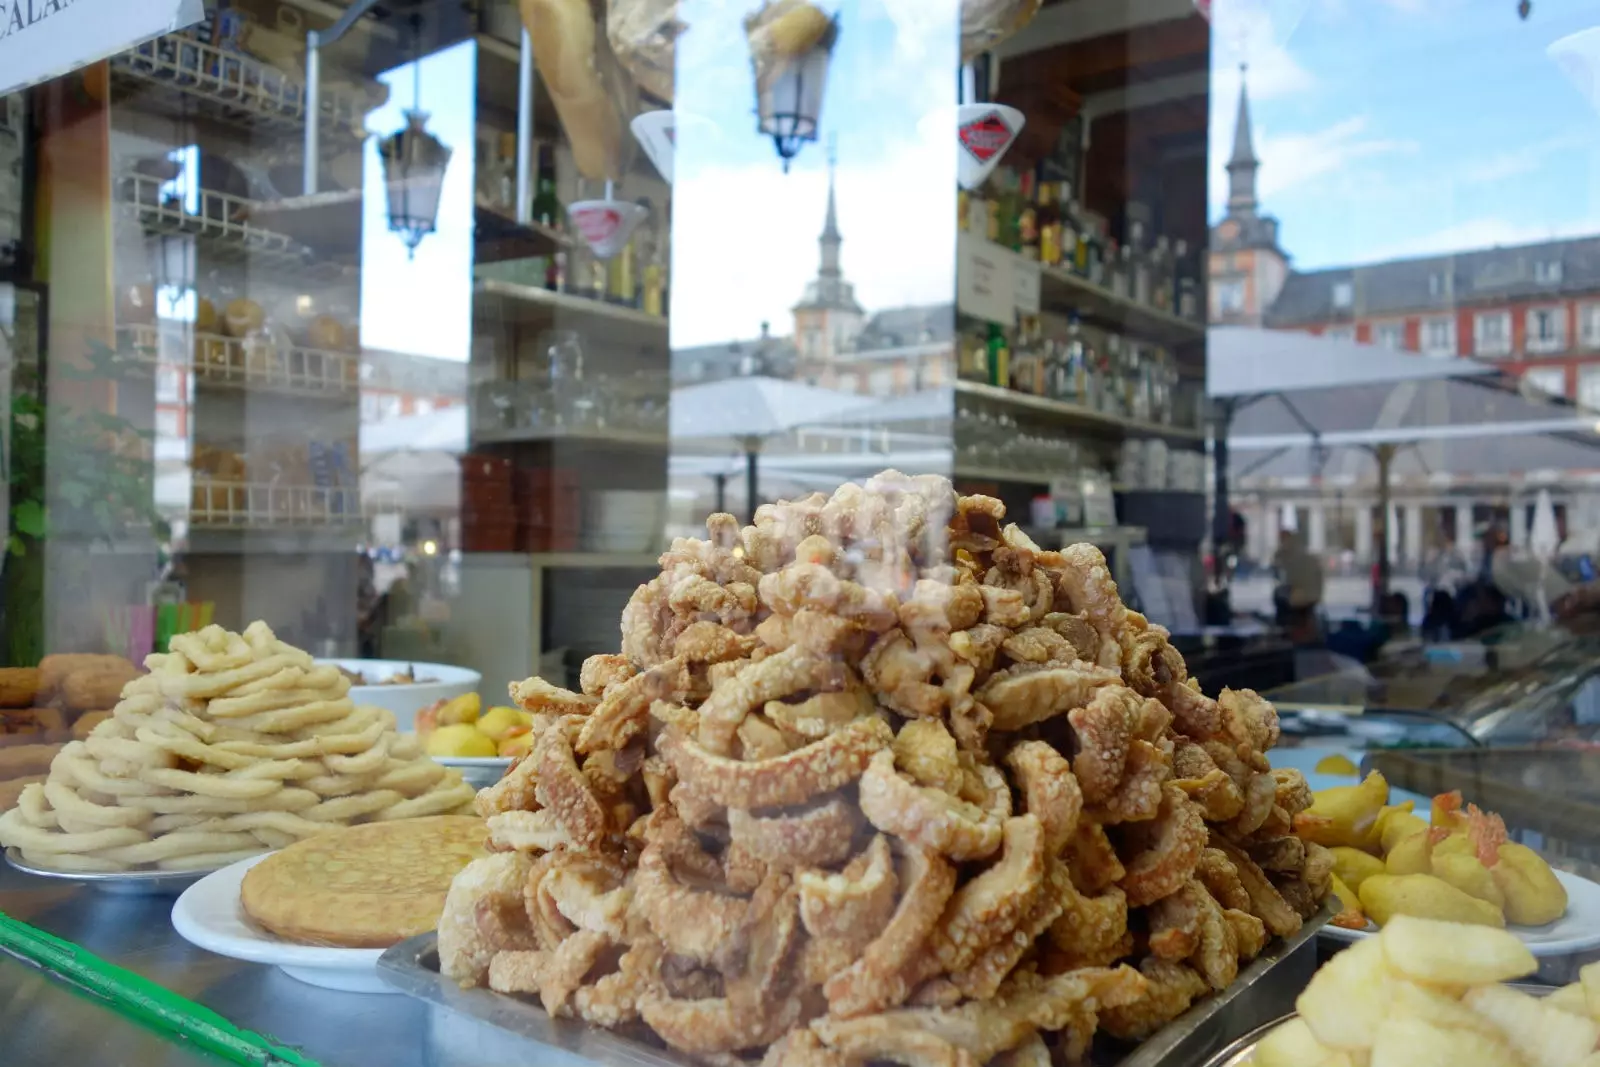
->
xmin=1210 ymin=0 xmax=1600 ymax=269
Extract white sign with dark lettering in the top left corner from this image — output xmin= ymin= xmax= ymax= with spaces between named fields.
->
xmin=0 ymin=0 xmax=205 ymax=96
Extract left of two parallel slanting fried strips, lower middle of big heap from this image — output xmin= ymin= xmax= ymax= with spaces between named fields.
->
xmin=802 ymin=841 xmax=955 ymax=1017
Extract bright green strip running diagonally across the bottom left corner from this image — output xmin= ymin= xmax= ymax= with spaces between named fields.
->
xmin=0 ymin=912 xmax=318 ymax=1067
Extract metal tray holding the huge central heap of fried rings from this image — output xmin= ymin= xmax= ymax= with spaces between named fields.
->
xmin=378 ymin=910 xmax=1331 ymax=1067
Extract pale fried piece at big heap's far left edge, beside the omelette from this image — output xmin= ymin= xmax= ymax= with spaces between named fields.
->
xmin=438 ymin=853 xmax=533 ymax=987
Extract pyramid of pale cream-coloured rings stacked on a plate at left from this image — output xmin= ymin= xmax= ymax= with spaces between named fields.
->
xmin=0 ymin=622 xmax=472 ymax=873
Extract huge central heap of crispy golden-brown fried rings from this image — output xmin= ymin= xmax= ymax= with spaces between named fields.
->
xmin=438 ymin=472 xmax=1333 ymax=1067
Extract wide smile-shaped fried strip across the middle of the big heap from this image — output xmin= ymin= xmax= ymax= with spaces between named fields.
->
xmin=656 ymin=717 xmax=894 ymax=809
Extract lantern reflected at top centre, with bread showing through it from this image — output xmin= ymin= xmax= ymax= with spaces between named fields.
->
xmin=746 ymin=5 xmax=838 ymax=173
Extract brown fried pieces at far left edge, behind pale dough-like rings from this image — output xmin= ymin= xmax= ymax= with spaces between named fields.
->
xmin=0 ymin=653 xmax=139 ymax=811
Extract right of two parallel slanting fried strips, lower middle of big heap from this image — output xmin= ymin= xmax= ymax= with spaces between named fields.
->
xmin=928 ymin=814 xmax=1045 ymax=974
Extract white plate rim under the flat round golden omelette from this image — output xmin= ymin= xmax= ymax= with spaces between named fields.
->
xmin=173 ymin=853 xmax=395 ymax=993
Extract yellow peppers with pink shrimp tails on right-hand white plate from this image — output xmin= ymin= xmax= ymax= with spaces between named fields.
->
xmin=1294 ymin=771 xmax=1566 ymax=929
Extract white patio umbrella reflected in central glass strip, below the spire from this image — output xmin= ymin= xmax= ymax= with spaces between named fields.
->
xmin=669 ymin=374 xmax=878 ymax=522
